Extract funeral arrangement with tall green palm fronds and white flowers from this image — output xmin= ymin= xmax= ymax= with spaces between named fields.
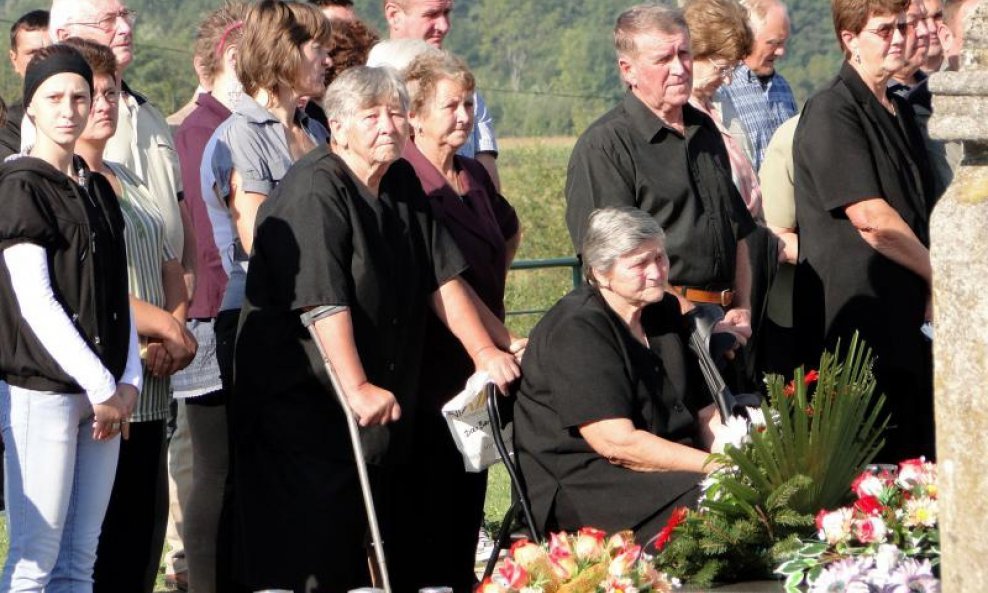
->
xmin=650 ymin=336 xmax=888 ymax=586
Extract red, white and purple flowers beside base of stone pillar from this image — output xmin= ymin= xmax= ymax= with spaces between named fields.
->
xmin=776 ymin=458 xmax=940 ymax=593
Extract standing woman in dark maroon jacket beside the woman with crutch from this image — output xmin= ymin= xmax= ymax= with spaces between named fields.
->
xmin=391 ymin=51 xmax=521 ymax=593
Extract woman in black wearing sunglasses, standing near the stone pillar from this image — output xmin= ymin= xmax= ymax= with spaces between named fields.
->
xmin=793 ymin=0 xmax=934 ymax=462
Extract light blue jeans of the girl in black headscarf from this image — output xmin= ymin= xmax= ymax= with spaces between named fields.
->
xmin=0 ymin=386 xmax=120 ymax=593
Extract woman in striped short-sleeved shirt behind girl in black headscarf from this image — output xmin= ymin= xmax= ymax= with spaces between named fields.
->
xmin=62 ymin=37 xmax=197 ymax=591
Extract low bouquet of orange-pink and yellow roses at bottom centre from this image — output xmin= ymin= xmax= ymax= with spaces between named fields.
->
xmin=478 ymin=527 xmax=678 ymax=593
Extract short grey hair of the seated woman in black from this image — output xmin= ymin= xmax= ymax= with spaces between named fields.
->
xmin=582 ymin=206 xmax=666 ymax=286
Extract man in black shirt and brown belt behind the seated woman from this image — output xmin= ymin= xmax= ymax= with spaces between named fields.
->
xmin=566 ymin=5 xmax=755 ymax=344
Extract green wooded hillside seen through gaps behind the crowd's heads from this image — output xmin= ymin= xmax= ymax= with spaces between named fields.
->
xmin=0 ymin=0 xmax=840 ymax=137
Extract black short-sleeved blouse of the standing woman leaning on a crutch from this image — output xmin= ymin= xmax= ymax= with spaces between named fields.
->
xmin=234 ymin=146 xmax=465 ymax=463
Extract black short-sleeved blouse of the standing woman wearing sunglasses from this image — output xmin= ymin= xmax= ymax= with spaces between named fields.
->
xmin=793 ymin=63 xmax=932 ymax=369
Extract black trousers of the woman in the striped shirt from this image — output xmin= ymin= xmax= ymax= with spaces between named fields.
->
xmin=93 ymin=420 xmax=168 ymax=593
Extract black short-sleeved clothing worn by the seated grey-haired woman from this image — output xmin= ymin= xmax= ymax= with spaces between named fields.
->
xmin=515 ymin=284 xmax=710 ymax=530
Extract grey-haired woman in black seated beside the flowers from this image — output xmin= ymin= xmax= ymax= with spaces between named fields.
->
xmin=515 ymin=208 xmax=720 ymax=541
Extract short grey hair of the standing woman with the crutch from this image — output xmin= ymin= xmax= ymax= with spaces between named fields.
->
xmin=323 ymin=66 xmax=408 ymax=121
